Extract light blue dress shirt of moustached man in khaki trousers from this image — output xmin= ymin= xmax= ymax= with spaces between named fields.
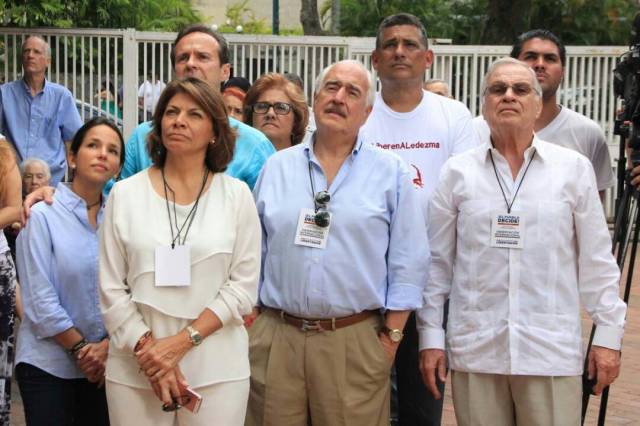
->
xmin=254 ymin=135 xmax=429 ymax=318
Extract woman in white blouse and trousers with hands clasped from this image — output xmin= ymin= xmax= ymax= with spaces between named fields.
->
xmin=100 ymin=77 xmax=262 ymax=426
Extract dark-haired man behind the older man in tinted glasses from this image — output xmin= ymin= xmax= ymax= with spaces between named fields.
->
xmin=473 ymin=29 xmax=615 ymax=199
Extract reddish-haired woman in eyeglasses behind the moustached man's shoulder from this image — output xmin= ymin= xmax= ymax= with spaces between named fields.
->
xmin=244 ymin=73 xmax=309 ymax=151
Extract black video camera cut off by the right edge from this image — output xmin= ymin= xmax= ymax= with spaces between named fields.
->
xmin=613 ymin=13 xmax=640 ymax=167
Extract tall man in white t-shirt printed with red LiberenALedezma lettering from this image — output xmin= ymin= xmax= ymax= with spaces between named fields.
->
xmin=361 ymin=13 xmax=477 ymax=426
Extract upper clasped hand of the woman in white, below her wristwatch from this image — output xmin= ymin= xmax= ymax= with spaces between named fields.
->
xmin=135 ymin=330 xmax=192 ymax=382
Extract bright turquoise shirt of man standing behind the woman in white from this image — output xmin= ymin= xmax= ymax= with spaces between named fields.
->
xmin=105 ymin=117 xmax=275 ymax=194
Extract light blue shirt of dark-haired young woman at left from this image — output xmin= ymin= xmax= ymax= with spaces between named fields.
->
xmin=16 ymin=183 xmax=107 ymax=379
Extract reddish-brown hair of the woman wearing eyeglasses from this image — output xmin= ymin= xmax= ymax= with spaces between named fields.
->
xmin=244 ymin=72 xmax=309 ymax=145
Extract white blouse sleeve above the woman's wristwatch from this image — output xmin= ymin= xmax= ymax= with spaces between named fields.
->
xmin=207 ymin=185 xmax=262 ymax=325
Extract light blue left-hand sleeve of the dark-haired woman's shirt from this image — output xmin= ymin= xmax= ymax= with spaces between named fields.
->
xmin=16 ymin=210 xmax=74 ymax=339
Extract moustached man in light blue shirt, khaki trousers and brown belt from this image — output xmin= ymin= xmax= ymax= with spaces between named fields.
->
xmin=247 ymin=61 xmax=429 ymax=426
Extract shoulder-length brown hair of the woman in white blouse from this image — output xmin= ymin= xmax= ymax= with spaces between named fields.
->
xmin=147 ymin=77 xmax=236 ymax=173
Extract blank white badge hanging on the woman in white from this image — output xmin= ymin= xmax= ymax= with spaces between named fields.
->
xmin=155 ymin=245 xmax=191 ymax=287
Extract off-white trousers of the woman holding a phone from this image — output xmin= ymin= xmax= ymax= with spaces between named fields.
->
xmin=106 ymin=379 xmax=249 ymax=426
